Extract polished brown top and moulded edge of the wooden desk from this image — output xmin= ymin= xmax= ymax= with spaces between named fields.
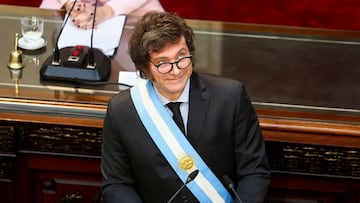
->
xmin=0 ymin=6 xmax=360 ymax=147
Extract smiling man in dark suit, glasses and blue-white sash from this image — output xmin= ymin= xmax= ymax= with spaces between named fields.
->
xmin=101 ymin=12 xmax=270 ymax=203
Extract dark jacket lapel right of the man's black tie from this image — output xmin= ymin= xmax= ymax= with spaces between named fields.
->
xmin=187 ymin=72 xmax=210 ymax=146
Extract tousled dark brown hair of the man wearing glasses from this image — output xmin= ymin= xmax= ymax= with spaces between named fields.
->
xmin=129 ymin=12 xmax=195 ymax=79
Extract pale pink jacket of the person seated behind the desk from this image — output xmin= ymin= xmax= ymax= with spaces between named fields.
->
xmin=40 ymin=0 xmax=164 ymax=15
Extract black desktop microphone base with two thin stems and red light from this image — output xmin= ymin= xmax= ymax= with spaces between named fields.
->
xmin=40 ymin=0 xmax=111 ymax=83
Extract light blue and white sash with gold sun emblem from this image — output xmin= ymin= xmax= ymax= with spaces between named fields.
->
xmin=130 ymin=81 xmax=233 ymax=203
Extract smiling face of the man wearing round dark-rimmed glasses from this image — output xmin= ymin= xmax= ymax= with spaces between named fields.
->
xmin=149 ymin=37 xmax=193 ymax=100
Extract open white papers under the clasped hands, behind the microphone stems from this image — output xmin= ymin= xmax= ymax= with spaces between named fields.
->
xmin=58 ymin=15 xmax=126 ymax=56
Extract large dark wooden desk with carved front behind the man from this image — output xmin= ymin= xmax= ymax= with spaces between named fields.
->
xmin=0 ymin=6 xmax=360 ymax=202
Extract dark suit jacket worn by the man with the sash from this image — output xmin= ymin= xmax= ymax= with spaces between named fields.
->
xmin=101 ymin=72 xmax=270 ymax=203
